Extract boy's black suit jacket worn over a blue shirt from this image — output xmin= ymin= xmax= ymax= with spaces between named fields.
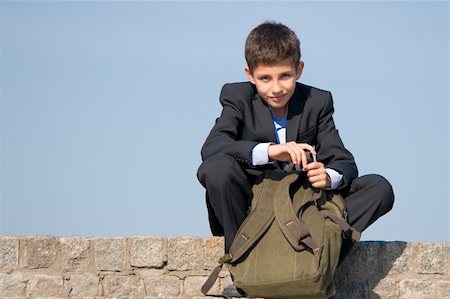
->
xmin=201 ymin=82 xmax=358 ymax=235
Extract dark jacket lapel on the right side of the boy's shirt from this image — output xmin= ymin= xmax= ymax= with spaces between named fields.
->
xmin=286 ymin=83 xmax=305 ymax=142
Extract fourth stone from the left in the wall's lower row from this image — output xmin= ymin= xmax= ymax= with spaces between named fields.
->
xmin=102 ymin=275 xmax=145 ymax=298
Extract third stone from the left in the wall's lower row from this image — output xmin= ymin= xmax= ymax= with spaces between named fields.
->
xmin=66 ymin=273 xmax=99 ymax=297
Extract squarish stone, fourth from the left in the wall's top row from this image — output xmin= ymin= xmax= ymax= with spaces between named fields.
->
xmin=94 ymin=238 xmax=127 ymax=271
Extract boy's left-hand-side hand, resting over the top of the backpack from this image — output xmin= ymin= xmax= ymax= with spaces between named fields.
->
xmin=268 ymin=141 xmax=316 ymax=171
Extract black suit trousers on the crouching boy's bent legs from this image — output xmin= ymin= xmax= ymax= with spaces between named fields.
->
xmin=197 ymin=154 xmax=394 ymax=256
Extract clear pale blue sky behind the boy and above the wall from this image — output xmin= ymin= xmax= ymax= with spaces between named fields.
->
xmin=0 ymin=1 xmax=450 ymax=242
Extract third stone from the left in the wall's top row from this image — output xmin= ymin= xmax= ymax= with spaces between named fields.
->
xmin=59 ymin=237 xmax=90 ymax=272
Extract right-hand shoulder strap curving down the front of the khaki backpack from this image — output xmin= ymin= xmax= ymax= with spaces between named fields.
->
xmin=273 ymin=173 xmax=321 ymax=251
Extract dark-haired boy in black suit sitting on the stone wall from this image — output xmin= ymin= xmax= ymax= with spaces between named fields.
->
xmin=197 ymin=22 xmax=394 ymax=298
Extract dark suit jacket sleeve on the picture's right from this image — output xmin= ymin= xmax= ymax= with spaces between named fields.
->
xmin=317 ymin=92 xmax=358 ymax=188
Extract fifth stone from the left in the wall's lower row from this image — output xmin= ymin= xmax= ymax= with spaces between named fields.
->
xmin=144 ymin=275 xmax=183 ymax=298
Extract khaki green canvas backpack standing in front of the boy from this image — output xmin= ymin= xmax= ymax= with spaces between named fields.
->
xmin=202 ymin=170 xmax=360 ymax=298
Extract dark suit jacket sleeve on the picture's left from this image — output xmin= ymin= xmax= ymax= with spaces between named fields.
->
xmin=201 ymin=84 xmax=258 ymax=165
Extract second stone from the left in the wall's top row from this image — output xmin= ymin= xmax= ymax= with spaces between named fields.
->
xmin=22 ymin=237 xmax=56 ymax=269
